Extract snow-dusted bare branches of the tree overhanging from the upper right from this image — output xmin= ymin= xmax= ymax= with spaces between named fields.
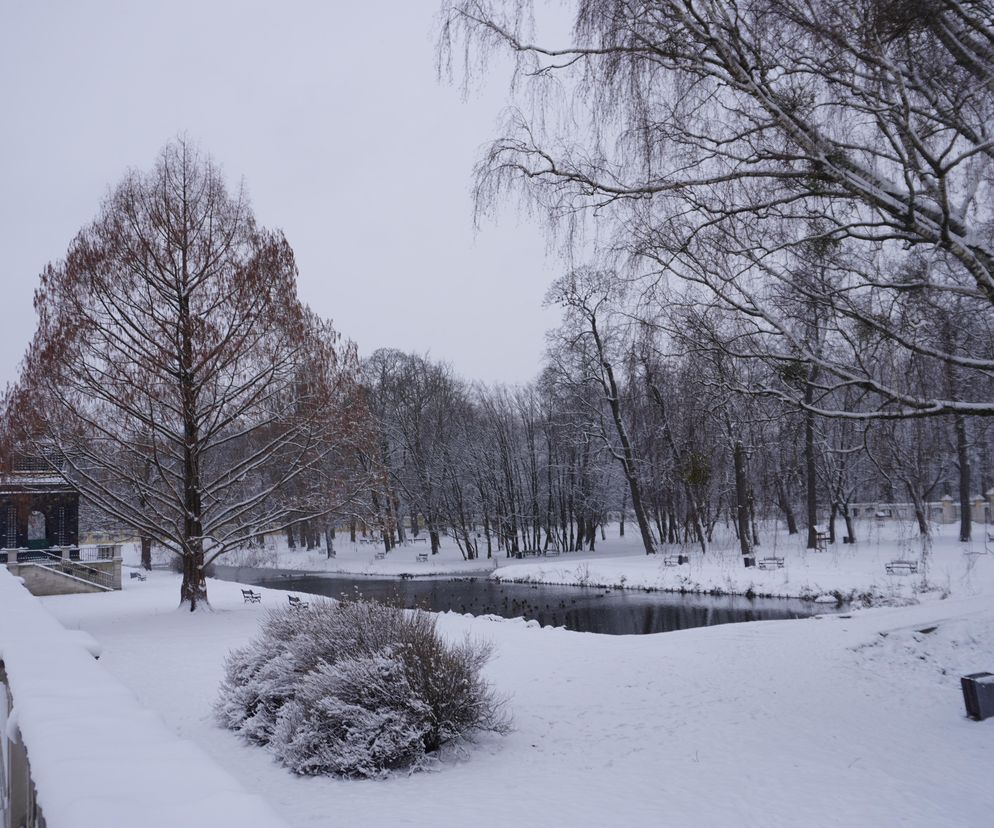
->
xmin=440 ymin=0 xmax=994 ymax=418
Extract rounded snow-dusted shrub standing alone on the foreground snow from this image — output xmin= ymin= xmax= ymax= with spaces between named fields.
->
xmin=216 ymin=600 xmax=507 ymax=777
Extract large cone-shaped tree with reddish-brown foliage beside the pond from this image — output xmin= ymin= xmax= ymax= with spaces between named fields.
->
xmin=7 ymin=140 xmax=360 ymax=611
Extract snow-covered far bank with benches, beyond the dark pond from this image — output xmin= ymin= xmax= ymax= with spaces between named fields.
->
xmin=184 ymin=520 xmax=994 ymax=603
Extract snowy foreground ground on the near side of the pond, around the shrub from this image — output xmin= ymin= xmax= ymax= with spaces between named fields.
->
xmin=44 ymin=568 xmax=994 ymax=828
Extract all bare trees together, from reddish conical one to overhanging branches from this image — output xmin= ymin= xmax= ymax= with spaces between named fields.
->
xmin=4 ymin=0 xmax=994 ymax=609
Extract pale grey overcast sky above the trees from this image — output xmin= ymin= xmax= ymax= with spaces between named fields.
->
xmin=0 ymin=0 xmax=561 ymax=383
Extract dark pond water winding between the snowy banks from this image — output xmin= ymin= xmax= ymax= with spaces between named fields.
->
xmin=216 ymin=566 xmax=834 ymax=635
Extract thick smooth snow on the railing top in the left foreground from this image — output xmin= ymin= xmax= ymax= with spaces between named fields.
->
xmin=0 ymin=567 xmax=285 ymax=828
